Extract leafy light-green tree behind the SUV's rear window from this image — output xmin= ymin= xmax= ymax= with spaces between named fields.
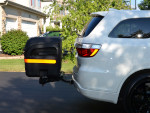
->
xmin=49 ymin=0 xmax=129 ymax=60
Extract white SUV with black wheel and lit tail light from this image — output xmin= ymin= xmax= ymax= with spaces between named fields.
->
xmin=73 ymin=10 xmax=150 ymax=113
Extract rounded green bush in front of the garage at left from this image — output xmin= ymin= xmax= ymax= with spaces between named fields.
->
xmin=1 ymin=30 xmax=29 ymax=55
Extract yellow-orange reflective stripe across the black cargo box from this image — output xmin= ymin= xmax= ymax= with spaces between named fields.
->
xmin=24 ymin=59 xmax=56 ymax=64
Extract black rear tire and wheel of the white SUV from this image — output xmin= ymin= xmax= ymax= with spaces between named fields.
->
xmin=121 ymin=74 xmax=150 ymax=113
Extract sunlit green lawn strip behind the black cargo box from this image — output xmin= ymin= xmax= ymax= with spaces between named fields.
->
xmin=0 ymin=59 xmax=74 ymax=73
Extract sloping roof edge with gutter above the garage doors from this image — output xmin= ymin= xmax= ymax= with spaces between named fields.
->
xmin=0 ymin=0 xmax=46 ymax=17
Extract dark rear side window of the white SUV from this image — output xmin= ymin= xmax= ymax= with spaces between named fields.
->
xmin=109 ymin=18 xmax=150 ymax=38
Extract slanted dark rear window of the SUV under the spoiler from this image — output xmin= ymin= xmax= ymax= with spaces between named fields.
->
xmin=82 ymin=16 xmax=104 ymax=37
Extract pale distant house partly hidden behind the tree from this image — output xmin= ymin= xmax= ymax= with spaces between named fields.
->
xmin=41 ymin=0 xmax=68 ymax=28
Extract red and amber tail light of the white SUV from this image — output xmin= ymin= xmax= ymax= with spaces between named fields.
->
xmin=76 ymin=44 xmax=101 ymax=57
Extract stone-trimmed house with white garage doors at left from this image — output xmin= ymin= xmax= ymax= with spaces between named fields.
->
xmin=0 ymin=0 xmax=46 ymax=37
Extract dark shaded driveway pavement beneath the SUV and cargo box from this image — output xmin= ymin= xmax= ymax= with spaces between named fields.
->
xmin=0 ymin=72 xmax=124 ymax=113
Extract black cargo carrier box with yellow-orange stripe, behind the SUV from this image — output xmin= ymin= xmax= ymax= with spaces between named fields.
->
xmin=24 ymin=37 xmax=62 ymax=81
